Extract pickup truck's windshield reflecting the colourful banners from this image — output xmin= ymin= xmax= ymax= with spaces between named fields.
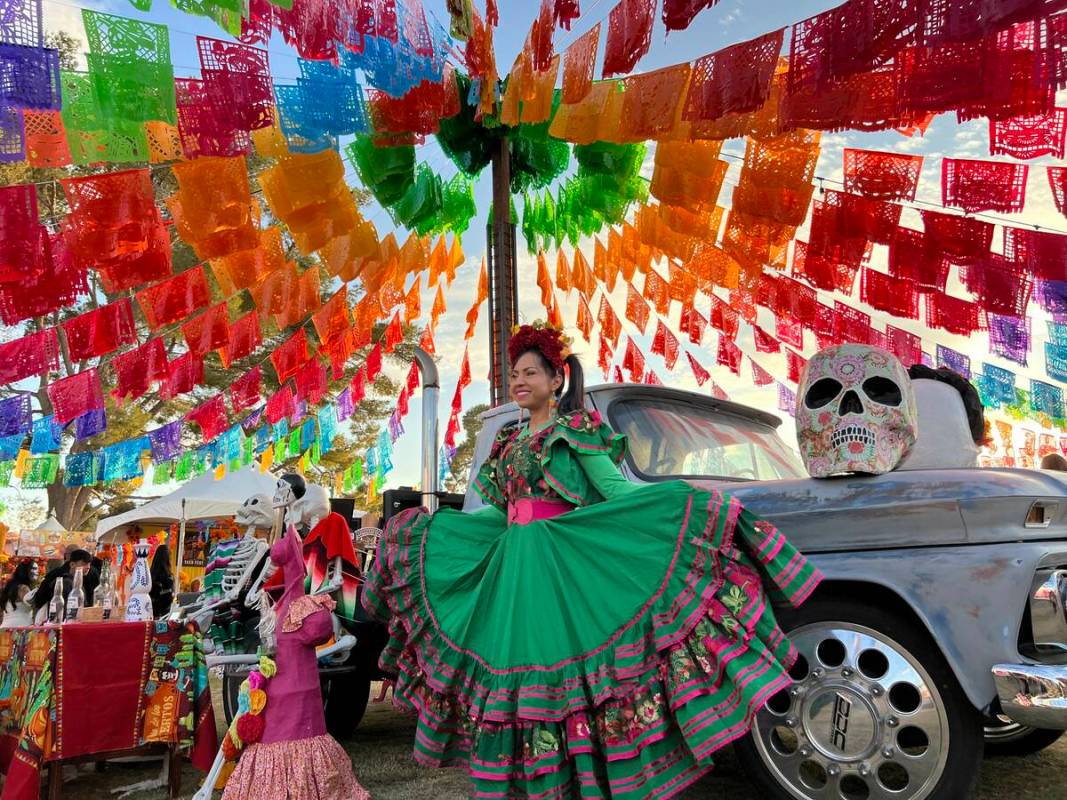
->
xmin=609 ymin=399 xmax=806 ymax=480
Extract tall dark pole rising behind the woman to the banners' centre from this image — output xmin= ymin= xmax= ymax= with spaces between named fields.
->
xmin=485 ymin=137 xmax=519 ymax=405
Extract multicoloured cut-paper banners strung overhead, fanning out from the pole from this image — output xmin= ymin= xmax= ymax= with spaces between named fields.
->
xmin=0 ymin=0 xmax=1067 ymax=486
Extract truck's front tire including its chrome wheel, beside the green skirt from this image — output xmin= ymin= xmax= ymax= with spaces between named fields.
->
xmin=736 ymin=598 xmax=983 ymax=800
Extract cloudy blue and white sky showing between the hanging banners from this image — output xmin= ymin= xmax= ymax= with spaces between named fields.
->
xmin=22 ymin=0 xmax=1067 ymax=501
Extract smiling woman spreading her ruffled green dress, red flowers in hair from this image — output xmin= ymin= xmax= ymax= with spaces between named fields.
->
xmin=363 ymin=325 xmax=819 ymax=800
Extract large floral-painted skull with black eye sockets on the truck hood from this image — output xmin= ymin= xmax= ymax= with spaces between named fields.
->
xmin=796 ymin=345 xmax=919 ymax=478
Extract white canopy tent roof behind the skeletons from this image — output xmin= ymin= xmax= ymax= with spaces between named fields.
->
xmin=96 ymin=466 xmax=276 ymax=542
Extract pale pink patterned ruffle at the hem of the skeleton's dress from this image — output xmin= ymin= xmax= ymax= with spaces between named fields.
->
xmin=222 ymin=735 xmax=370 ymax=800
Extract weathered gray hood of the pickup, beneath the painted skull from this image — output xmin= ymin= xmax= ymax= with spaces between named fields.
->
xmin=691 ymin=469 xmax=1067 ymax=553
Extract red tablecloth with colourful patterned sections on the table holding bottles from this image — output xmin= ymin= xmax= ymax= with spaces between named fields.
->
xmin=0 ymin=622 xmax=217 ymax=800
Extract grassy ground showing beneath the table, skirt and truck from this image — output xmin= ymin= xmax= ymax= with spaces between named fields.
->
xmin=37 ymin=689 xmax=1067 ymax=800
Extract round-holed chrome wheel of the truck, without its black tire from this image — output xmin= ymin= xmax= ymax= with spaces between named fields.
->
xmin=752 ymin=622 xmax=949 ymax=800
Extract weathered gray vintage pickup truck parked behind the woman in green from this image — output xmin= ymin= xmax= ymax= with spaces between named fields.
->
xmin=464 ymin=384 xmax=1067 ymax=800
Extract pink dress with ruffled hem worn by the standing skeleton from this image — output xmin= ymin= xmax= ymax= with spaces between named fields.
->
xmin=222 ymin=526 xmax=370 ymax=800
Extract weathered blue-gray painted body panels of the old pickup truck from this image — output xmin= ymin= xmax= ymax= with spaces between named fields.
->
xmin=464 ymin=384 xmax=1067 ymax=708
